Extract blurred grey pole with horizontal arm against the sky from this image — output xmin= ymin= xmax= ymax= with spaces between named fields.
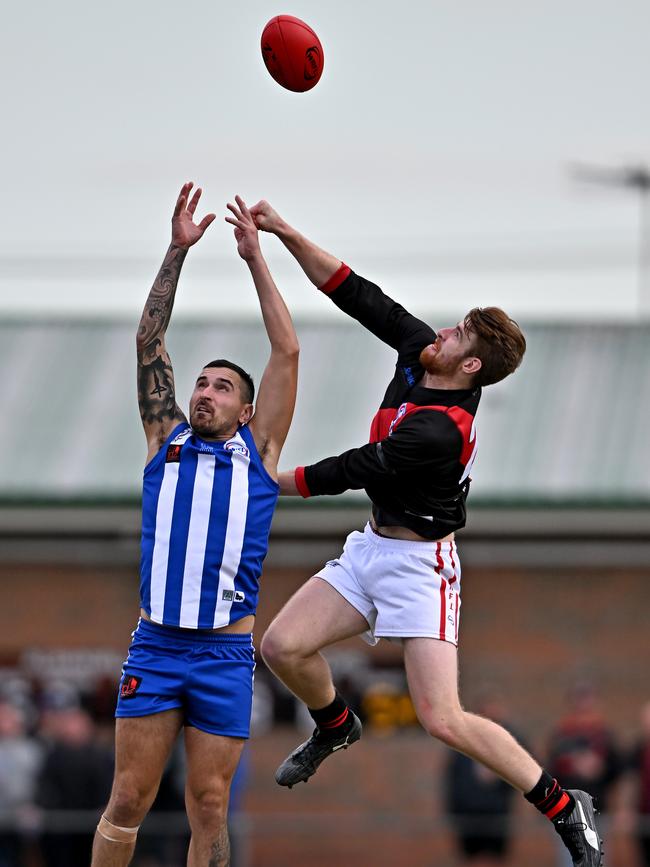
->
xmin=572 ymin=164 xmax=650 ymax=317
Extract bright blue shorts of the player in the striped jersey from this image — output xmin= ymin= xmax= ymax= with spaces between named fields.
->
xmin=115 ymin=620 xmax=255 ymax=738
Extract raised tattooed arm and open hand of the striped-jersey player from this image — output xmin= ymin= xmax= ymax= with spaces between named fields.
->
xmin=136 ymin=183 xmax=215 ymax=462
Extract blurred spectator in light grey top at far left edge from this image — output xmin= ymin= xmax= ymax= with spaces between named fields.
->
xmin=0 ymin=701 xmax=41 ymax=867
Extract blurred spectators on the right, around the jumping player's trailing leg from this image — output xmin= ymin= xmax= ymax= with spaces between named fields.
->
xmin=445 ymin=683 xmax=650 ymax=867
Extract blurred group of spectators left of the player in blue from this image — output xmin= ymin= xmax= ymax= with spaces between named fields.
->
xmin=0 ymin=679 xmax=113 ymax=867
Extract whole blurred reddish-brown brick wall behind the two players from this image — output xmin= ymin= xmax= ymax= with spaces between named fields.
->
xmin=0 ymin=564 xmax=650 ymax=867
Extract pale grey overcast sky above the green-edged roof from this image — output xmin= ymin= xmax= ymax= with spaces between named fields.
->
xmin=0 ymin=0 xmax=650 ymax=324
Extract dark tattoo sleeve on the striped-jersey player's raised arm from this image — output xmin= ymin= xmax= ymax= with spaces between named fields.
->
xmin=137 ymin=247 xmax=187 ymax=424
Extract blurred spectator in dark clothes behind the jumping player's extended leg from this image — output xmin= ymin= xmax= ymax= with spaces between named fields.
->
xmin=445 ymin=693 xmax=516 ymax=867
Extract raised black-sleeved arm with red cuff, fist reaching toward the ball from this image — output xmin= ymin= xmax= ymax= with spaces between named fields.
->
xmin=251 ymin=201 xmax=436 ymax=358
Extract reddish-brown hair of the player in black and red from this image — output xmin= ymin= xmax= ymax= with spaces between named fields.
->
xmin=465 ymin=307 xmax=526 ymax=386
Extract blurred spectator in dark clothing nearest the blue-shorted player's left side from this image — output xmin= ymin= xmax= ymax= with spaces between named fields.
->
xmin=36 ymin=705 xmax=113 ymax=867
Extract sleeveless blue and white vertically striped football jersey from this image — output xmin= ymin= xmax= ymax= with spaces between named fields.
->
xmin=140 ymin=422 xmax=279 ymax=629
